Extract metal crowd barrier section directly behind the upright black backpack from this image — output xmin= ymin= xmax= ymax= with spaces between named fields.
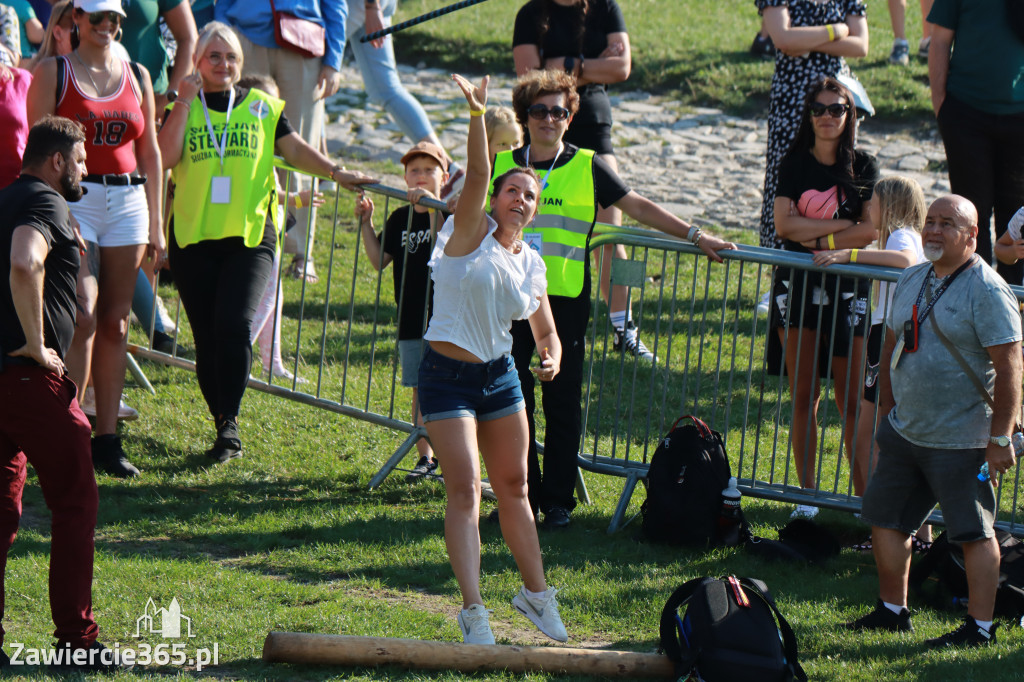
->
xmin=579 ymin=226 xmax=1024 ymax=534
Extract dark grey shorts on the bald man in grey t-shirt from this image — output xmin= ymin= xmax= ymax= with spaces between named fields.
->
xmin=861 ymin=419 xmax=995 ymax=543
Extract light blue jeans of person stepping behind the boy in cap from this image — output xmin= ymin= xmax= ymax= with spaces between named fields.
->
xmin=348 ymin=0 xmax=434 ymax=142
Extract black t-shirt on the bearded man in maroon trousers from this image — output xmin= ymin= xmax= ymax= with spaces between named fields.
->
xmin=0 ymin=175 xmax=81 ymax=359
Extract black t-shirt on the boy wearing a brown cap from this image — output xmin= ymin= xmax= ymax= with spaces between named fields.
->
xmin=378 ymin=206 xmax=447 ymax=341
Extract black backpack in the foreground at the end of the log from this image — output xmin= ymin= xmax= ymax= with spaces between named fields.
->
xmin=660 ymin=576 xmax=807 ymax=682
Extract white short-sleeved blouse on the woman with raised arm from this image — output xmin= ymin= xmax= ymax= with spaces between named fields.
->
xmin=423 ymin=216 xmax=548 ymax=360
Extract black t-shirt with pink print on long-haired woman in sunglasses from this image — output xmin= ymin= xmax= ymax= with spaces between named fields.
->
xmin=775 ymin=150 xmax=879 ymax=291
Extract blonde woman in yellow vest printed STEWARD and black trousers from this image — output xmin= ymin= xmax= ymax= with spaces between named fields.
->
xmin=159 ymin=22 xmax=376 ymax=464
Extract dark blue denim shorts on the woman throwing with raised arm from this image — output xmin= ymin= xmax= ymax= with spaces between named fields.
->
xmin=419 ymin=345 xmax=525 ymax=423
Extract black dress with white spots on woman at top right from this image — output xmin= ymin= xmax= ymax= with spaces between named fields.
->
xmin=755 ymin=0 xmax=865 ymax=248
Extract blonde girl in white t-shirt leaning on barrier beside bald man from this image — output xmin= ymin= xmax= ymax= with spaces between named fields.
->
xmin=814 ymin=175 xmax=927 ymax=495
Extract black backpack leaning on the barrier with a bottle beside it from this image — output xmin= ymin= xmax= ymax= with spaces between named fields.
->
xmin=641 ymin=415 xmax=749 ymax=547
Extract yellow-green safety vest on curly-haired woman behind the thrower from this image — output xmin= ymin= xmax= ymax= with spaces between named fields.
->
xmin=492 ymin=150 xmax=597 ymax=298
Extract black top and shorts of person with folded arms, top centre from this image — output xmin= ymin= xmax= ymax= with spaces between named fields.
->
xmin=512 ymin=0 xmax=626 ymax=124
